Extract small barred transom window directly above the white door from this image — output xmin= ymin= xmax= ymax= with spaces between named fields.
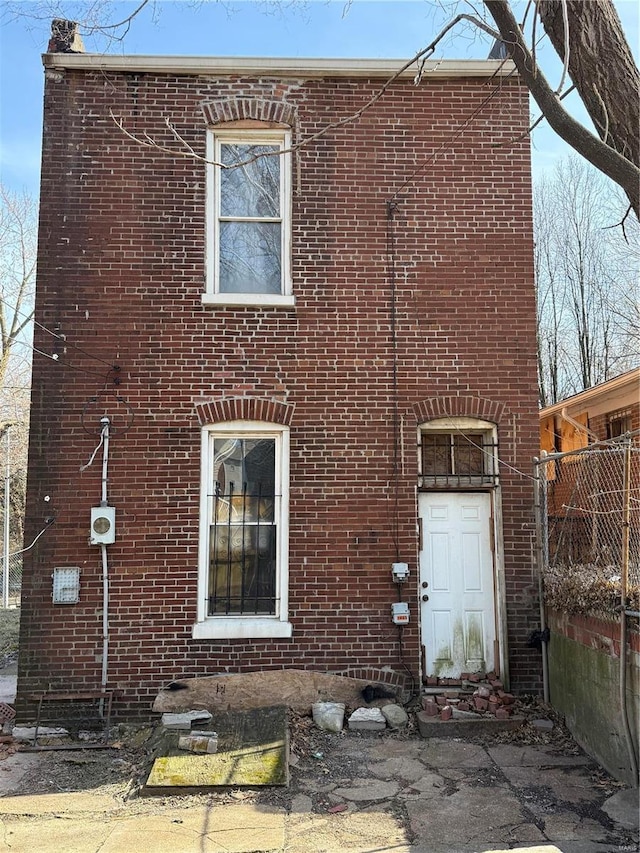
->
xmin=420 ymin=431 xmax=497 ymax=488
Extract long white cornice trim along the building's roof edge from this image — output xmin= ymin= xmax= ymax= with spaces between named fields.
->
xmin=42 ymin=53 xmax=514 ymax=81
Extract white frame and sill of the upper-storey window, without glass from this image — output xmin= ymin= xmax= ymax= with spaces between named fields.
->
xmin=202 ymin=128 xmax=295 ymax=308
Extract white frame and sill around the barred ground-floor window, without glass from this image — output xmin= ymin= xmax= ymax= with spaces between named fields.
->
xmin=192 ymin=421 xmax=293 ymax=640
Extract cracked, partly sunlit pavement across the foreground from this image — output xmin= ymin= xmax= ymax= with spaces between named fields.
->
xmin=0 ymin=732 xmax=638 ymax=853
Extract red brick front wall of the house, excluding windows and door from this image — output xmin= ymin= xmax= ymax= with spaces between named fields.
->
xmin=19 ymin=71 xmax=539 ymax=714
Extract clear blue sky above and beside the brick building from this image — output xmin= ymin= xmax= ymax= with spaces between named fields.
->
xmin=0 ymin=0 xmax=640 ymax=195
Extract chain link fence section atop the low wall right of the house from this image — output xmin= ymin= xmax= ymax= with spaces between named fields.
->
xmin=536 ymin=435 xmax=640 ymax=613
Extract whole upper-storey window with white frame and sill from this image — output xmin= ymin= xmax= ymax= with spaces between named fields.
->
xmin=203 ymin=127 xmax=294 ymax=306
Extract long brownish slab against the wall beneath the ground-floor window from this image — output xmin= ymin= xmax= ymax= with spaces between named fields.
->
xmin=153 ymin=669 xmax=398 ymax=714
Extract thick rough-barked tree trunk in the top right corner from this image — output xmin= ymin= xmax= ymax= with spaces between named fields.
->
xmin=538 ymin=0 xmax=640 ymax=167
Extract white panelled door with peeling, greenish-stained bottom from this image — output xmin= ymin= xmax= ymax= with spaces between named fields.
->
xmin=418 ymin=492 xmax=498 ymax=678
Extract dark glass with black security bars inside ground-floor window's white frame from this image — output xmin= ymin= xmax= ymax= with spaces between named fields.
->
xmin=208 ymin=438 xmax=280 ymax=616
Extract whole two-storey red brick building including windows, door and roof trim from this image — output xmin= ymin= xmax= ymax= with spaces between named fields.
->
xmin=18 ymin=43 xmax=538 ymax=715
